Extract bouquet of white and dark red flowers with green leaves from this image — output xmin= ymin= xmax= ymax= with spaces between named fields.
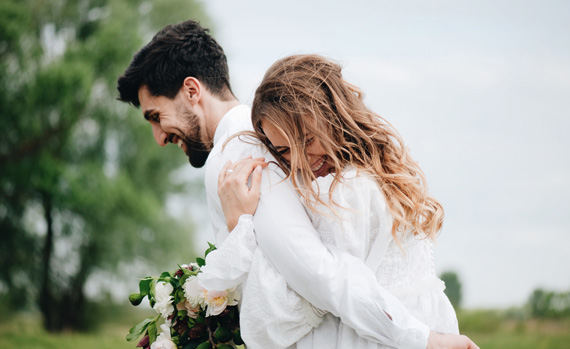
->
xmin=127 ymin=243 xmax=243 ymax=349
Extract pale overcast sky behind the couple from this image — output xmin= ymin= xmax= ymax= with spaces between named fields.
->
xmin=179 ymin=0 xmax=570 ymax=308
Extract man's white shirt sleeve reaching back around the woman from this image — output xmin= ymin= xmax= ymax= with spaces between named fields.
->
xmin=254 ymin=170 xmax=429 ymax=348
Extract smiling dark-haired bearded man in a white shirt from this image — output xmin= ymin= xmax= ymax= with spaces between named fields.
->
xmin=117 ymin=21 xmax=477 ymax=348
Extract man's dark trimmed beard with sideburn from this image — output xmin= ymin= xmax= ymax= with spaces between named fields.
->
xmin=178 ymin=108 xmax=212 ymax=168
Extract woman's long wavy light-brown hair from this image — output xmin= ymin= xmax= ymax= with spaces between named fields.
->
xmin=252 ymin=55 xmax=443 ymax=241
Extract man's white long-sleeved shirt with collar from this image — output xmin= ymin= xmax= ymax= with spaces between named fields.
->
xmin=200 ymin=105 xmax=429 ymax=349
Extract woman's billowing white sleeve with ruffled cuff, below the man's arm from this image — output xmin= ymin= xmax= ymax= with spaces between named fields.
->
xmin=198 ymin=215 xmax=324 ymax=348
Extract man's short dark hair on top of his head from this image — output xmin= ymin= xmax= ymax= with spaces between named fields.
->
xmin=117 ymin=20 xmax=233 ymax=107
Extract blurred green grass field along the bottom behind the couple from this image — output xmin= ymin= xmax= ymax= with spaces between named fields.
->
xmin=0 ymin=308 xmax=570 ymax=349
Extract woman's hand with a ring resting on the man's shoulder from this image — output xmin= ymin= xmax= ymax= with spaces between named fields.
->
xmin=218 ymin=156 xmax=267 ymax=232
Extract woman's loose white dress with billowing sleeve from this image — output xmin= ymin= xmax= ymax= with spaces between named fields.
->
xmin=199 ymin=168 xmax=459 ymax=348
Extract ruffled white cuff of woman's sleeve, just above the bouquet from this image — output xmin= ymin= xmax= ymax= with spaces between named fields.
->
xmin=198 ymin=215 xmax=257 ymax=290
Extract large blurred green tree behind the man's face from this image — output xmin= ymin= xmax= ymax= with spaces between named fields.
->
xmin=0 ymin=0 xmax=210 ymax=331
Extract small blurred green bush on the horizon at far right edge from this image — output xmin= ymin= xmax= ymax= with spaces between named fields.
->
xmin=527 ymin=288 xmax=570 ymax=318
